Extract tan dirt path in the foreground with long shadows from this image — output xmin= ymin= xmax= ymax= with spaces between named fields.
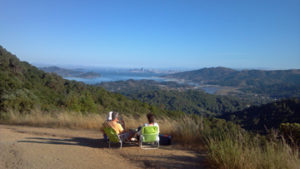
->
xmin=0 ymin=125 xmax=204 ymax=169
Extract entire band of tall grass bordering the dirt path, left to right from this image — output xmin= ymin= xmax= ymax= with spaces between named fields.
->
xmin=0 ymin=110 xmax=300 ymax=169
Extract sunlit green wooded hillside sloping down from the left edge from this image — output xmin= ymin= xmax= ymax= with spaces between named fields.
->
xmin=0 ymin=46 xmax=182 ymax=117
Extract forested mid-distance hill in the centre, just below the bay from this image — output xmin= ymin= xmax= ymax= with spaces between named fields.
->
xmin=100 ymin=80 xmax=249 ymax=115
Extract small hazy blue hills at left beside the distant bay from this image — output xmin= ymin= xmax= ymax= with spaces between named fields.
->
xmin=39 ymin=66 xmax=101 ymax=79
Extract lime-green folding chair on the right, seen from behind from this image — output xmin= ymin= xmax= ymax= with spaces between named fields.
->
xmin=140 ymin=126 xmax=159 ymax=149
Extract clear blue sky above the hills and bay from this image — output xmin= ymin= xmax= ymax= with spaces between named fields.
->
xmin=0 ymin=0 xmax=300 ymax=69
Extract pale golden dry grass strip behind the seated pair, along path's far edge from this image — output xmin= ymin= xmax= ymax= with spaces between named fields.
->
xmin=0 ymin=110 xmax=176 ymax=133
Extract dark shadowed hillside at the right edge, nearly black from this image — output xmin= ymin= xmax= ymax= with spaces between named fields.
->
xmin=220 ymin=98 xmax=300 ymax=132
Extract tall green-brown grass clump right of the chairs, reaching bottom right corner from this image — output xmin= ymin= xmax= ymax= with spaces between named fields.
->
xmin=170 ymin=117 xmax=300 ymax=169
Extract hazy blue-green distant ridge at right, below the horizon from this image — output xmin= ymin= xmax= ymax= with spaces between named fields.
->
xmin=166 ymin=67 xmax=300 ymax=98
